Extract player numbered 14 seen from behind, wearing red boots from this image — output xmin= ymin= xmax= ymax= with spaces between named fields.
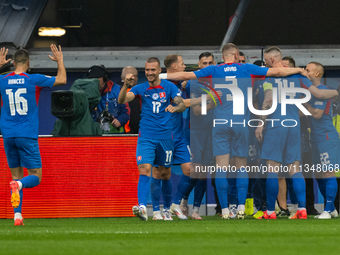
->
xmin=255 ymin=46 xmax=337 ymax=219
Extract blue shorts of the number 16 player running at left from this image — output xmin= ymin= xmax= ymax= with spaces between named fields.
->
xmin=3 ymin=137 xmax=41 ymax=169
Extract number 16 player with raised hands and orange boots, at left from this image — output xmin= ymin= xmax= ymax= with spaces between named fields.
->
xmin=0 ymin=44 xmax=66 ymax=226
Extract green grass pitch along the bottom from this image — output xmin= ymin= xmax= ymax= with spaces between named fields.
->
xmin=0 ymin=216 xmax=340 ymax=255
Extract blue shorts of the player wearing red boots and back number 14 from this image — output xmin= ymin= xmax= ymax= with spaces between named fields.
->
xmin=261 ymin=127 xmax=301 ymax=165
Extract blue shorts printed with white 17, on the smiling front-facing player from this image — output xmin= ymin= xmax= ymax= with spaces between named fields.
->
xmin=136 ymin=137 xmax=174 ymax=168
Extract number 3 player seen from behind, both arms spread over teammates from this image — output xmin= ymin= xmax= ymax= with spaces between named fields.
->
xmin=161 ymin=43 xmax=310 ymax=219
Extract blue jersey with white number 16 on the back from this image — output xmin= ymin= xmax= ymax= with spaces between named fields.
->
xmin=0 ymin=72 xmax=55 ymax=139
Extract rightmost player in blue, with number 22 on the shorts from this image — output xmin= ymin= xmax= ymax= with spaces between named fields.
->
xmin=306 ymin=62 xmax=340 ymax=219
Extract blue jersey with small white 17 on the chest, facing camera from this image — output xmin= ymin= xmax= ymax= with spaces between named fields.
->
xmin=130 ymin=80 xmax=181 ymax=139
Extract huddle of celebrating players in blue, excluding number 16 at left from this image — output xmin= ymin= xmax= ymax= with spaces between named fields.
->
xmin=119 ymin=43 xmax=340 ymax=220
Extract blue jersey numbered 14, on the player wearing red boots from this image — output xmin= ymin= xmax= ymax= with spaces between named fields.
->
xmin=261 ymin=74 xmax=313 ymax=129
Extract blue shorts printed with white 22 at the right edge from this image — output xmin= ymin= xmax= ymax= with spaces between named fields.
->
xmin=310 ymin=139 xmax=340 ymax=172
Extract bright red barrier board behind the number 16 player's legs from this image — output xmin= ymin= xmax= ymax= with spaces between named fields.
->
xmin=0 ymin=137 xmax=139 ymax=218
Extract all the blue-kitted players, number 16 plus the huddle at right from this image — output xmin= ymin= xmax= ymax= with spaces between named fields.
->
xmin=0 ymin=43 xmax=340 ymax=225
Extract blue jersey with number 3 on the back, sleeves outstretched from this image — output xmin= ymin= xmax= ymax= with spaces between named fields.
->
xmin=194 ymin=63 xmax=268 ymax=125
